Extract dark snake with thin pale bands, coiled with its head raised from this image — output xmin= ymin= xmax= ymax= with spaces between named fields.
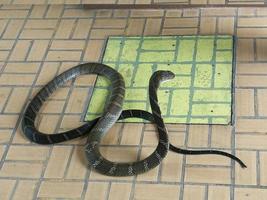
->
xmin=22 ymin=63 xmax=246 ymax=176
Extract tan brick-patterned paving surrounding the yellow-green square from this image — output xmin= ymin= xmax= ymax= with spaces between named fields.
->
xmin=0 ymin=5 xmax=267 ymax=200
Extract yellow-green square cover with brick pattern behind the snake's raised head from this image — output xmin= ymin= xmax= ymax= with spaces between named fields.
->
xmin=86 ymin=35 xmax=234 ymax=124
